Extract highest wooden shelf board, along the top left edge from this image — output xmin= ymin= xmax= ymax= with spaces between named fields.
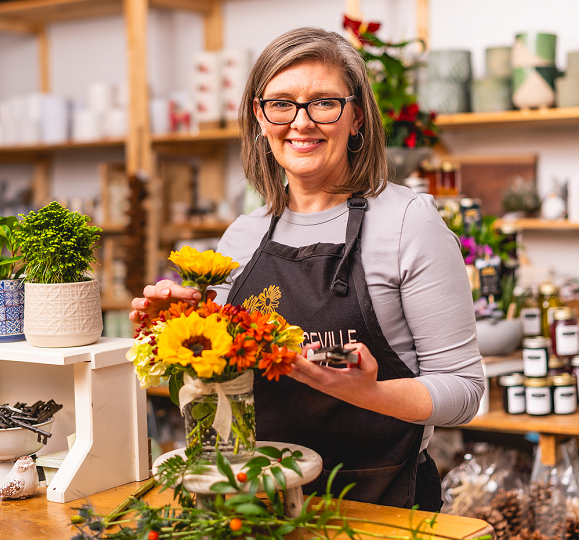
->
xmin=0 ymin=0 xmax=214 ymax=33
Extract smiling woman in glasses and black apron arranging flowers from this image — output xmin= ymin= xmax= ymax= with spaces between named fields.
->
xmin=131 ymin=28 xmax=483 ymax=510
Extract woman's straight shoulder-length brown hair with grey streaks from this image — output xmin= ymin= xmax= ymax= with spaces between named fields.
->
xmin=239 ymin=27 xmax=387 ymax=215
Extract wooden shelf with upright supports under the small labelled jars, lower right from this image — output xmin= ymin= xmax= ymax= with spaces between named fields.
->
xmin=461 ymin=381 xmax=579 ymax=465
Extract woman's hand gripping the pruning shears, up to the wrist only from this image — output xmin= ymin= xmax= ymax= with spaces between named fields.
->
xmin=288 ymin=343 xmax=378 ymax=409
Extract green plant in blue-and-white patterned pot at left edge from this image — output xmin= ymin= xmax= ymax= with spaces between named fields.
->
xmin=0 ymin=216 xmax=24 ymax=343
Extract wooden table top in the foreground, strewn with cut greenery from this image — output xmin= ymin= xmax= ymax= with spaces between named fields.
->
xmin=0 ymin=482 xmax=493 ymax=540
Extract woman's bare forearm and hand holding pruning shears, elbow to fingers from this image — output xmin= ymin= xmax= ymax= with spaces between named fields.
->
xmin=288 ymin=343 xmax=433 ymax=422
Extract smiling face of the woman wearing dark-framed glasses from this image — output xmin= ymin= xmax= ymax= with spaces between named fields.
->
xmin=254 ymin=61 xmax=363 ymax=190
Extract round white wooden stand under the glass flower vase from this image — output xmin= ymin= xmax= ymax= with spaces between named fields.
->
xmin=153 ymin=441 xmax=322 ymax=517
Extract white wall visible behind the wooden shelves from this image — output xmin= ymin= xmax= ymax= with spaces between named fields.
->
xmin=0 ymin=0 xmax=579 ymax=275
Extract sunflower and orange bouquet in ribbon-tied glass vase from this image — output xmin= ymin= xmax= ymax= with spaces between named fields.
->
xmin=127 ymin=246 xmax=303 ymax=457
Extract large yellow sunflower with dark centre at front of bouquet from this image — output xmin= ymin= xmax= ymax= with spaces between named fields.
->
xmin=159 ymin=312 xmax=233 ymax=379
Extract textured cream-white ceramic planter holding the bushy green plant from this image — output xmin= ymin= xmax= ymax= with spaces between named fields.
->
xmin=24 ymin=280 xmax=103 ymax=347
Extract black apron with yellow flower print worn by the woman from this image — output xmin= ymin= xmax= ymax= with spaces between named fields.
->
xmin=228 ymin=197 xmax=423 ymax=508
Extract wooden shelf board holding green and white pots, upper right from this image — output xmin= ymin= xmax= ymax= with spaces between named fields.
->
xmin=435 ymin=107 xmax=579 ymax=131
